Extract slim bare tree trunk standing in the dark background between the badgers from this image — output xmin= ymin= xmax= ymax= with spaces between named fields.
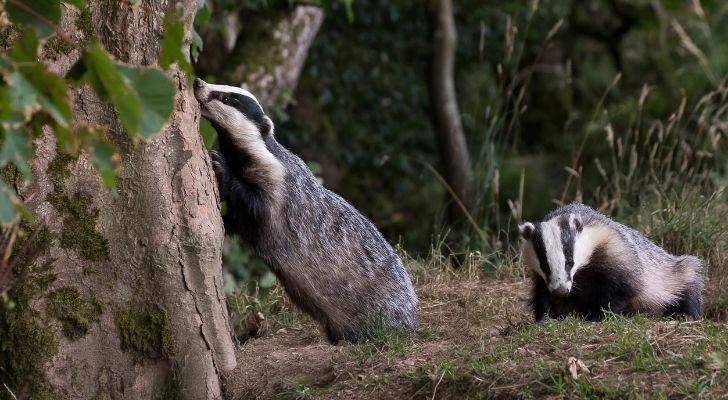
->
xmin=429 ymin=0 xmax=475 ymax=223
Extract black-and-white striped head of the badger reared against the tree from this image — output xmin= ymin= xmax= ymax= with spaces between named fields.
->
xmin=193 ymin=78 xmax=283 ymax=180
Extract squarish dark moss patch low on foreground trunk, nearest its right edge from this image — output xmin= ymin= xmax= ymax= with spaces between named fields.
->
xmin=114 ymin=307 xmax=175 ymax=357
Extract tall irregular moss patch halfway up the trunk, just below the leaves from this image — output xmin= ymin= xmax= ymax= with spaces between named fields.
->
xmin=47 ymin=152 xmax=110 ymax=261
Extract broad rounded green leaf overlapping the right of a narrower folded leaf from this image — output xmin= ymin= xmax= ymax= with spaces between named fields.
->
xmin=118 ymin=66 xmax=176 ymax=138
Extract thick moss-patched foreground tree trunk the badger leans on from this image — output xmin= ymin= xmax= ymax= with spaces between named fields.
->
xmin=0 ymin=0 xmax=235 ymax=399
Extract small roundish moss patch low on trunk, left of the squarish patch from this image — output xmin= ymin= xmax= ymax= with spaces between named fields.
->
xmin=48 ymin=287 xmax=101 ymax=340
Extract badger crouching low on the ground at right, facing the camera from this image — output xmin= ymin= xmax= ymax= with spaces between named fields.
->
xmin=518 ymin=203 xmax=703 ymax=321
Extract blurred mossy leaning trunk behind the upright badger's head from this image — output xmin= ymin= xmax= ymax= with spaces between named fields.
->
xmin=195 ymin=5 xmax=324 ymax=107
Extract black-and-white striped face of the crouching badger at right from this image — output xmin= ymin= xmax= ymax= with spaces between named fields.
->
xmin=518 ymin=214 xmax=583 ymax=296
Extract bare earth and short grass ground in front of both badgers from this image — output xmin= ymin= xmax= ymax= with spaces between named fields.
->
xmin=225 ymin=278 xmax=728 ymax=400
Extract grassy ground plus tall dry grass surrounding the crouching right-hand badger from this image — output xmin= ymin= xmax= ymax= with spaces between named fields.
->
xmin=225 ymin=78 xmax=728 ymax=399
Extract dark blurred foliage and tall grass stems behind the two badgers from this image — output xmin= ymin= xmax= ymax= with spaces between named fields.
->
xmin=200 ymin=0 xmax=728 ymax=294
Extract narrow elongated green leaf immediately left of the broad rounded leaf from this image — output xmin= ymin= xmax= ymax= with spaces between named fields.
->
xmin=84 ymin=42 xmax=141 ymax=138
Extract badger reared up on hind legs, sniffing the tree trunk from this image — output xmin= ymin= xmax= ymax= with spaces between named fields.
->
xmin=194 ymin=79 xmax=417 ymax=342
